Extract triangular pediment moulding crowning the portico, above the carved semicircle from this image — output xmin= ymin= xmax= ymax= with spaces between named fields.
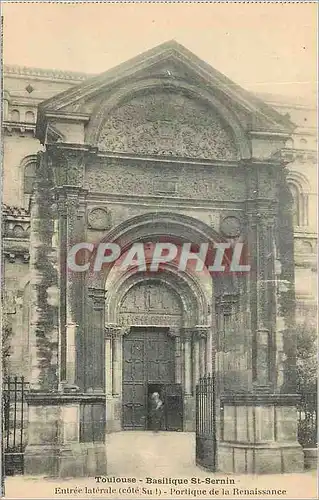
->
xmin=37 ymin=41 xmax=295 ymax=151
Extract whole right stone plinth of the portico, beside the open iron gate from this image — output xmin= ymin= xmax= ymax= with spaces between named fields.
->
xmin=217 ymin=394 xmax=304 ymax=474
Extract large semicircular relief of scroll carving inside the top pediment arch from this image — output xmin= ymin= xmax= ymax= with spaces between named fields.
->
xmin=97 ymin=91 xmax=238 ymax=160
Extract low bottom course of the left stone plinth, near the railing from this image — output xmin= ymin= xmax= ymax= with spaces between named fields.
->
xmin=24 ymin=443 xmax=107 ymax=478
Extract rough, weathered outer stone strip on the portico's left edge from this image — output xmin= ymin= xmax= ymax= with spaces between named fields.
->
xmin=29 ymin=153 xmax=59 ymax=391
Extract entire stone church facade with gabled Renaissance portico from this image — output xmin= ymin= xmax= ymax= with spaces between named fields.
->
xmin=3 ymin=42 xmax=317 ymax=475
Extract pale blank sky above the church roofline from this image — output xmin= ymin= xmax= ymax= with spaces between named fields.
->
xmin=2 ymin=2 xmax=318 ymax=100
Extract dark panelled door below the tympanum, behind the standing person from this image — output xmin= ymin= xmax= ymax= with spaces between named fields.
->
xmin=122 ymin=327 xmax=183 ymax=431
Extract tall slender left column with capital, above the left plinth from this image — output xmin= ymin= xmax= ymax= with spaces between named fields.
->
xmin=47 ymin=144 xmax=87 ymax=390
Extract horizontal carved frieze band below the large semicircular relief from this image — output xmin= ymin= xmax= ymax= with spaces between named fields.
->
xmin=85 ymin=159 xmax=246 ymax=201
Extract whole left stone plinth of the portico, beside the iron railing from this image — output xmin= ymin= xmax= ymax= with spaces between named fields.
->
xmin=25 ymin=393 xmax=107 ymax=477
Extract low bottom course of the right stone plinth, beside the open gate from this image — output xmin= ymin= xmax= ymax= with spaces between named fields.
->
xmin=217 ymin=442 xmax=304 ymax=474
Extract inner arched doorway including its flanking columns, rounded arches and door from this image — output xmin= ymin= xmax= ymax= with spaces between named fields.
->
xmin=106 ymin=266 xmax=211 ymax=431
